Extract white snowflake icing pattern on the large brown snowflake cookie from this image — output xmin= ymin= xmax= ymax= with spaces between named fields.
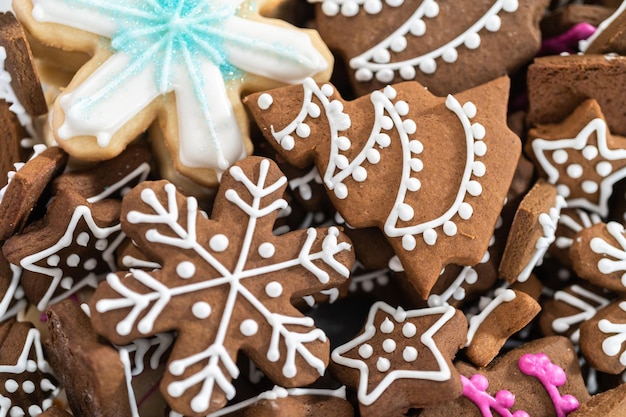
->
xmin=96 ymin=159 xmax=351 ymax=413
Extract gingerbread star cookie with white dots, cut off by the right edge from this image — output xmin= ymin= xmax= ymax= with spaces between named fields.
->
xmin=526 ymin=100 xmax=626 ymax=217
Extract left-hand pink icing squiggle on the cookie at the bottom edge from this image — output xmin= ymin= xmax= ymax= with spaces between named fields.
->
xmin=461 ymin=374 xmax=528 ymax=417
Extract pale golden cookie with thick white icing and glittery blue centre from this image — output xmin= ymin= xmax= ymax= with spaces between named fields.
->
xmin=13 ymin=0 xmax=333 ymax=186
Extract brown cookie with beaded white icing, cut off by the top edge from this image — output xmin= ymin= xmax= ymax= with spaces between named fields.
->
xmin=309 ymin=0 xmax=548 ymax=95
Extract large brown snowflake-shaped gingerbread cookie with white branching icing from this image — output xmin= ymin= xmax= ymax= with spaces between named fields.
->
xmin=90 ymin=157 xmax=354 ymax=416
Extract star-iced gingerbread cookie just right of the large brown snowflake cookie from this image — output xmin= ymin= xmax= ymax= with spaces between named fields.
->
xmin=331 ymin=302 xmax=467 ymax=416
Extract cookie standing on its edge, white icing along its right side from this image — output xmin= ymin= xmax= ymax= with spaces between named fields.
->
xmin=498 ymin=180 xmax=566 ymax=282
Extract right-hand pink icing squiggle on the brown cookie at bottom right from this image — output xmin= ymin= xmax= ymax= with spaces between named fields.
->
xmin=518 ymin=353 xmax=579 ymax=417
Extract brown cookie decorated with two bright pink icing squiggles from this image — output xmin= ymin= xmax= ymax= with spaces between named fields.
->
xmin=420 ymin=336 xmax=590 ymax=417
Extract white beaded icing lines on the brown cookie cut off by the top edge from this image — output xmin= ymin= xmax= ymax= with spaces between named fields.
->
xmin=352 ymin=0 xmax=519 ymax=83
